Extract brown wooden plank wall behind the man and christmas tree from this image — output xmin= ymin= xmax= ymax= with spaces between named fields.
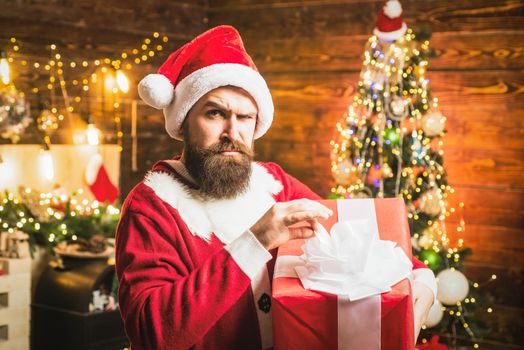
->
xmin=0 ymin=0 xmax=524 ymax=349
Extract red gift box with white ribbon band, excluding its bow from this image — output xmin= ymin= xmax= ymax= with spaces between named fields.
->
xmin=272 ymin=198 xmax=415 ymax=350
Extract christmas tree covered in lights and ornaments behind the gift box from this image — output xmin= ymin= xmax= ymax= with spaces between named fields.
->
xmin=331 ymin=0 xmax=496 ymax=347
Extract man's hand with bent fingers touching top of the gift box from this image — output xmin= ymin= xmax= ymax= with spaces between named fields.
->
xmin=250 ymin=199 xmax=333 ymax=250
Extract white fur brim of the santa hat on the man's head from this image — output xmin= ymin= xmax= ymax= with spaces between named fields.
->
xmin=164 ymin=63 xmax=274 ymax=140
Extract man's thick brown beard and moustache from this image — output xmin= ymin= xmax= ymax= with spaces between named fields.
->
xmin=184 ymin=139 xmax=254 ymax=199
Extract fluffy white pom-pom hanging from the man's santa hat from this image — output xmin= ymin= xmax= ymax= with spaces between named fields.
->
xmin=138 ymin=74 xmax=175 ymax=109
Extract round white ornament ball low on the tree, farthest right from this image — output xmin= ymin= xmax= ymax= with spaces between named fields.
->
xmin=437 ymin=269 xmax=469 ymax=305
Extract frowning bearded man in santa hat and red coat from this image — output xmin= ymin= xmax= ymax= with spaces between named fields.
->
xmin=116 ymin=26 xmax=436 ymax=350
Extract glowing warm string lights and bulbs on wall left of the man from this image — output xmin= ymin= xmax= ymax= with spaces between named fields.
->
xmin=0 ymin=32 xmax=169 ymax=187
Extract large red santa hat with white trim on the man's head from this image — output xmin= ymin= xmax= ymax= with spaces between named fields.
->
xmin=138 ymin=26 xmax=274 ymax=140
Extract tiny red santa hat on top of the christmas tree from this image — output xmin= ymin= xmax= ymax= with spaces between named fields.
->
xmin=373 ymin=0 xmax=408 ymax=40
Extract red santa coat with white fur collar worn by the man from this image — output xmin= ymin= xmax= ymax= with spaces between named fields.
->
xmin=116 ymin=161 xmax=436 ymax=350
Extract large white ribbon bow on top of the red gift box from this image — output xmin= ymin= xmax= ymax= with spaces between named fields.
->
xmin=295 ymin=220 xmax=412 ymax=301
